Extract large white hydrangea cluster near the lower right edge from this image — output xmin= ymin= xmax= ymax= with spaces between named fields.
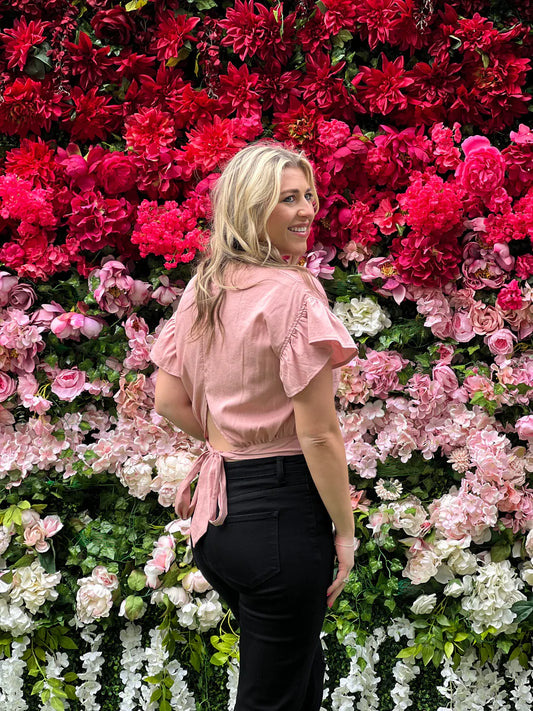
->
xmin=461 ymin=560 xmax=526 ymax=634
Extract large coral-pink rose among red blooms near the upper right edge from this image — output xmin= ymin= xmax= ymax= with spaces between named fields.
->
xmin=455 ymin=136 xmax=505 ymax=198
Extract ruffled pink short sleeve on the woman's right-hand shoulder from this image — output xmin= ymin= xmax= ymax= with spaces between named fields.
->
xmin=280 ymin=296 xmax=357 ymax=397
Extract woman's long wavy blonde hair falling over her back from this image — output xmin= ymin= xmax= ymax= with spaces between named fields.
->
xmin=192 ymin=141 xmax=318 ymax=342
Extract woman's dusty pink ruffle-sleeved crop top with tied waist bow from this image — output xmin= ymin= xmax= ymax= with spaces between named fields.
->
xmin=151 ymin=265 xmax=357 ymax=545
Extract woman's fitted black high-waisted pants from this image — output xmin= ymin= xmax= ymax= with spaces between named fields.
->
xmin=194 ymin=455 xmax=334 ymax=711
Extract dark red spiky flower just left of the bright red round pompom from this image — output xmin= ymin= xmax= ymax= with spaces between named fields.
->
xmin=63 ymin=86 xmax=120 ymax=141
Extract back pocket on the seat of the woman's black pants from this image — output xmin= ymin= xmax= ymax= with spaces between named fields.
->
xmin=204 ymin=511 xmax=280 ymax=590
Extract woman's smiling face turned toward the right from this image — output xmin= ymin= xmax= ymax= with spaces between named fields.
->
xmin=266 ymin=168 xmax=315 ymax=260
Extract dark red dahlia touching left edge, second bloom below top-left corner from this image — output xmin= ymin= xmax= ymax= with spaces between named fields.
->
xmin=0 ymin=77 xmax=61 ymax=138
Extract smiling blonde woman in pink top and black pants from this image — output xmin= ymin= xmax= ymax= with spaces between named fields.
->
xmin=152 ymin=143 xmax=355 ymax=711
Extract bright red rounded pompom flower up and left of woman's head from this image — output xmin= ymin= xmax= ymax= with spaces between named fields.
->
xmin=125 ymin=107 xmax=176 ymax=160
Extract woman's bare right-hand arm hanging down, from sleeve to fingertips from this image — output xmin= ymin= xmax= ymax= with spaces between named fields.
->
xmin=293 ymin=364 xmax=354 ymax=607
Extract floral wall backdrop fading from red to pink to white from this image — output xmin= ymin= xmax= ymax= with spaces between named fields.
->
xmin=0 ymin=0 xmax=533 ymax=711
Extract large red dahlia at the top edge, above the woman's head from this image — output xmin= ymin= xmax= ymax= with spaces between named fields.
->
xmin=218 ymin=0 xmax=296 ymax=63
